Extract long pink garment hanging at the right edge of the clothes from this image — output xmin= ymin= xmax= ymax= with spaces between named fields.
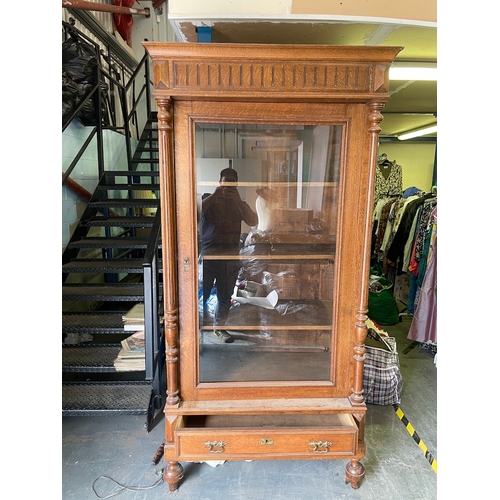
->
xmin=408 ymin=234 xmax=437 ymax=343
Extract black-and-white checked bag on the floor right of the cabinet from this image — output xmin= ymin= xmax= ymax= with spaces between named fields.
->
xmin=363 ymin=328 xmax=403 ymax=405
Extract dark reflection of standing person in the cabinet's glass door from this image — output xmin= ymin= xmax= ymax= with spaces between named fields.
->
xmin=201 ymin=168 xmax=258 ymax=343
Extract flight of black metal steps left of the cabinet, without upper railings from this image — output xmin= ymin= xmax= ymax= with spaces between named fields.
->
xmin=62 ymin=113 xmax=165 ymax=430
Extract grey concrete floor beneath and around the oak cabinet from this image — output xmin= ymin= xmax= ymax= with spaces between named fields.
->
xmin=62 ymin=316 xmax=437 ymax=500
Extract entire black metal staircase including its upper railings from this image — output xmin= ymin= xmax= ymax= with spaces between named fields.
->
xmin=62 ymin=20 xmax=166 ymax=432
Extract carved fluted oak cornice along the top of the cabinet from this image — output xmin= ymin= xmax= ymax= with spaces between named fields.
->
xmin=144 ymin=42 xmax=400 ymax=101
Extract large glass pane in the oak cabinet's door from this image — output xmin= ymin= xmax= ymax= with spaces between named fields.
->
xmin=195 ymin=123 xmax=343 ymax=383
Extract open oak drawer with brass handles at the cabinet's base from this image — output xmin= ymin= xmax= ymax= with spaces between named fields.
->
xmin=176 ymin=414 xmax=358 ymax=460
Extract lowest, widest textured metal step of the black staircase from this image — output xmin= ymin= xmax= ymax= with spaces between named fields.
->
xmin=62 ymin=382 xmax=152 ymax=416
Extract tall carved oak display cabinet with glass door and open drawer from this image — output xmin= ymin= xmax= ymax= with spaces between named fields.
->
xmin=144 ymin=42 xmax=401 ymax=490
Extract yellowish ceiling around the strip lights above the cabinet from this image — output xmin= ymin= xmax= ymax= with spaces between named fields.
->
xmin=172 ymin=19 xmax=437 ymax=138
